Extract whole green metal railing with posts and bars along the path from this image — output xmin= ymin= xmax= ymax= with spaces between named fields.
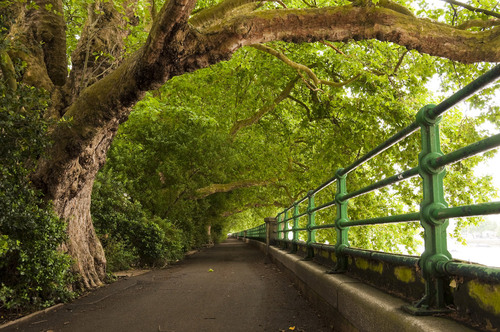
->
xmin=234 ymin=65 xmax=500 ymax=314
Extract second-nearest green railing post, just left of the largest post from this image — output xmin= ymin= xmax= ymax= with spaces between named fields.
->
xmin=330 ymin=168 xmax=349 ymax=273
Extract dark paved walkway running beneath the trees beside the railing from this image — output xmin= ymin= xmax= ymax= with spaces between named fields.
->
xmin=2 ymin=239 xmax=331 ymax=332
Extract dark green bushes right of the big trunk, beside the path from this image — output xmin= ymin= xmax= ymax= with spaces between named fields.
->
xmin=92 ymin=172 xmax=184 ymax=271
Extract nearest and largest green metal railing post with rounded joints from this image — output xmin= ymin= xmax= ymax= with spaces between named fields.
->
xmin=405 ymin=105 xmax=451 ymax=315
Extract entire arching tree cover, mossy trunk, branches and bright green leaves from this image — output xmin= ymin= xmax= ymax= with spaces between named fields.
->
xmin=0 ymin=0 xmax=500 ymax=314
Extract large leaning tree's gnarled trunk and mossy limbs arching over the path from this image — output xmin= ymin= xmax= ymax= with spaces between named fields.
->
xmin=0 ymin=0 xmax=500 ymax=288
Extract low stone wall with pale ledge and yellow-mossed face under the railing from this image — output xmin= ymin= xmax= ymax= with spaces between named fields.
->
xmin=244 ymin=239 xmax=500 ymax=332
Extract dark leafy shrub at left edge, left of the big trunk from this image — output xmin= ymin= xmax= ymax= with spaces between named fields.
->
xmin=0 ymin=77 xmax=72 ymax=313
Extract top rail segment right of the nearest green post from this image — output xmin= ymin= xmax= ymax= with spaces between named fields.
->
xmin=427 ymin=65 xmax=500 ymax=119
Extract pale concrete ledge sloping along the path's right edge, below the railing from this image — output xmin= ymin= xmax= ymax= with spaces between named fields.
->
xmin=244 ymin=239 xmax=473 ymax=332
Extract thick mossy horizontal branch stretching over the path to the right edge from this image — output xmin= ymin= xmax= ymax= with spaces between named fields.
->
xmin=207 ymin=6 xmax=500 ymax=63
